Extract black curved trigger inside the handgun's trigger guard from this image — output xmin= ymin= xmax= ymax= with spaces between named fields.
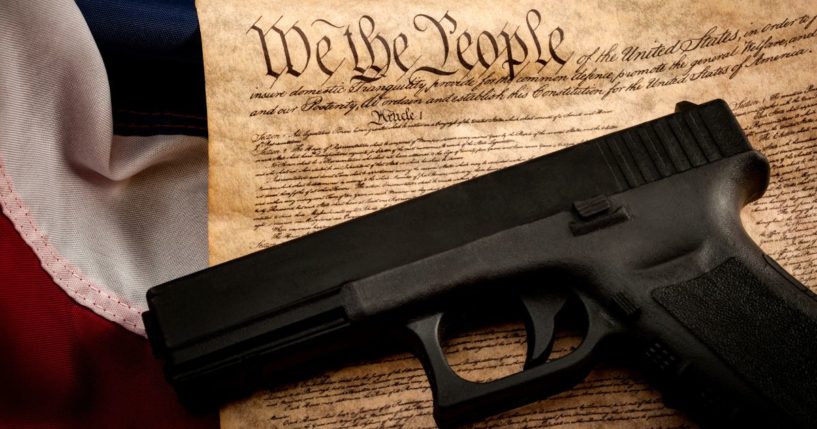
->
xmin=521 ymin=288 xmax=568 ymax=369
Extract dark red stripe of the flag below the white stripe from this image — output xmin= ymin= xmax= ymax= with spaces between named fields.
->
xmin=0 ymin=211 xmax=218 ymax=428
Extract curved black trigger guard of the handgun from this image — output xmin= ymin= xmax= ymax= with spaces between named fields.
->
xmin=407 ymin=299 xmax=619 ymax=427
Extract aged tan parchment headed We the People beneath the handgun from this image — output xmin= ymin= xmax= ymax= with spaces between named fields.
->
xmin=197 ymin=0 xmax=817 ymax=428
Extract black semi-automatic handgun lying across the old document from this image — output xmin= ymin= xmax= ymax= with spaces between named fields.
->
xmin=143 ymin=100 xmax=817 ymax=427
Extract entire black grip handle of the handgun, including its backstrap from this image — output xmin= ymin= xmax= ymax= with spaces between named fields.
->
xmin=652 ymin=252 xmax=817 ymax=427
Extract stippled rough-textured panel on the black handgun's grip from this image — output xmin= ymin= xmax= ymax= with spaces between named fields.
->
xmin=652 ymin=258 xmax=817 ymax=427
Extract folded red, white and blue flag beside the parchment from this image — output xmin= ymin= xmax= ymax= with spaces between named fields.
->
xmin=0 ymin=0 xmax=218 ymax=427
